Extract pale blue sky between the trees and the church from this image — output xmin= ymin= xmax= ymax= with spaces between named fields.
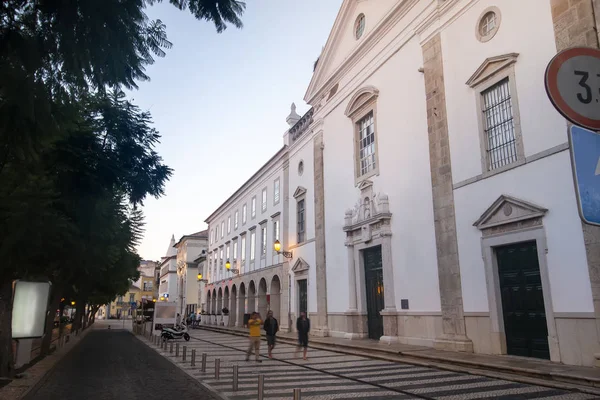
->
xmin=129 ymin=0 xmax=342 ymax=260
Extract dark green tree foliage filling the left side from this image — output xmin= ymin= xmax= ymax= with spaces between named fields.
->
xmin=0 ymin=0 xmax=245 ymax=376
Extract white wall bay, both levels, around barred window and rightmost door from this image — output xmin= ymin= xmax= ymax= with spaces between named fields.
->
xmin=442 ymin=0 xmax=593 ymax=312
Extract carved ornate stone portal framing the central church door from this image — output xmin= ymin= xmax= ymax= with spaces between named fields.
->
xmin=344 ymin=180 xmax=398 ymax=343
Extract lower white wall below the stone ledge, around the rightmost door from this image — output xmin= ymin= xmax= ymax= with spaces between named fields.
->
xmin=454 ymin=151 xmax=594 ymax=312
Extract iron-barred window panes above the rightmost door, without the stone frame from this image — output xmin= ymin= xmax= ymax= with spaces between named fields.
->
xmin=481 ymin=78 xmax=517 ymax=171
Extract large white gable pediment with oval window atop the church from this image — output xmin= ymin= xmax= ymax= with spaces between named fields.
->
xmin=304 ymin=0 xmax=403 ymax=106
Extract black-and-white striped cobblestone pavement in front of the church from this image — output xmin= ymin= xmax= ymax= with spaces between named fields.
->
xmin=154 ymin=331 xmax=595 ymax=400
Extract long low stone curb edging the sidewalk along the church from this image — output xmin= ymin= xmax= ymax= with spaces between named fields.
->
xmin=199 ymin=325 xmax=600 ymax=396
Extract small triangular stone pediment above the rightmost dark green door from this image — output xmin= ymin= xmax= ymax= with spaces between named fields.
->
xmin=473 ymin=195 xmax=548 ymax=230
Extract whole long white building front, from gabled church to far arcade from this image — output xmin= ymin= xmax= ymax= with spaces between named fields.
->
xmin=205 ymin=0 xmax=600 ymax=365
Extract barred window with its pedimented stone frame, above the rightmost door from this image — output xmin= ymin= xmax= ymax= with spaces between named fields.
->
xmin=467 ymin=53 xmax=525 ymax=177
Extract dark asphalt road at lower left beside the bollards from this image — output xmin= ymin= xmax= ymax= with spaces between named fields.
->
xmin=26 ymin=330 xmax=215 ymax=400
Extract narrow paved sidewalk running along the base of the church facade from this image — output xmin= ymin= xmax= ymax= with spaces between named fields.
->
xmin=200 ymin=325 xmax=600 ymax=394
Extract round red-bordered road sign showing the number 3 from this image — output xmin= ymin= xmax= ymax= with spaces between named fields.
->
xmin=545 ymin=47 xmax=600 ymax=131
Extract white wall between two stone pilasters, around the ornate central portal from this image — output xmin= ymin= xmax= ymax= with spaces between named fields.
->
xmin=324 ymin=35 xmax=440 ymax=312
